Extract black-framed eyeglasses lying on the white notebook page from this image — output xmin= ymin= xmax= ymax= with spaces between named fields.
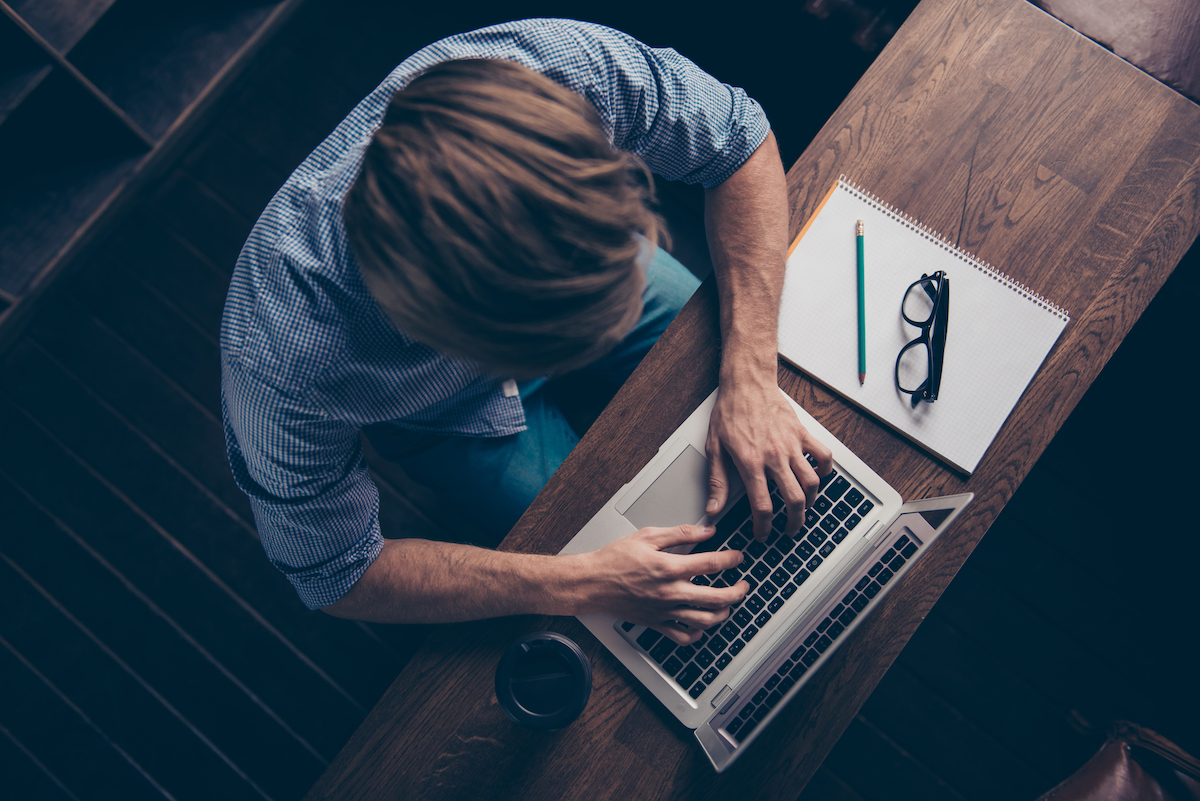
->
xmin=896 ymin=270 xmax=950 ymax=409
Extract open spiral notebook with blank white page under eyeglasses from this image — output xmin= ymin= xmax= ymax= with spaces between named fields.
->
xmin=779 ymin=176 xmax=1070 ymax=474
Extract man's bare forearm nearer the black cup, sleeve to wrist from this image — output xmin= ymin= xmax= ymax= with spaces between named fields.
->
xmin=325 ymin=540 xmax=584 ymax=624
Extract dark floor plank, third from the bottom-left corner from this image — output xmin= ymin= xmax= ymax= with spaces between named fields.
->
xmin=0 ymin=556 xmax=262 ymax=801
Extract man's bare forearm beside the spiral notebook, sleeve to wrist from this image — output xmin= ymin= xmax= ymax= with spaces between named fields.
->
xmin=704 ymin=133 xmax=788 ymax=384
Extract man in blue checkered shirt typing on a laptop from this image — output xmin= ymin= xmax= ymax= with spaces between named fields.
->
xmin=222 ymin=19 xmax=830 ymax=643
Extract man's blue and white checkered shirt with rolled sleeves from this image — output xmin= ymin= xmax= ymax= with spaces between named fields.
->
xmin=221 ymin=19 xmax=768 ymax=609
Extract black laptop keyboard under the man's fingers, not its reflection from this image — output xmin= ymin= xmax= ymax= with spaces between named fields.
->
xmin=622 ymin=457 xmax=875 ymax=698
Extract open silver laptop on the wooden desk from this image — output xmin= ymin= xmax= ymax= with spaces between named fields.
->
xmin=562 ymin=391 xmax=973 ymax=772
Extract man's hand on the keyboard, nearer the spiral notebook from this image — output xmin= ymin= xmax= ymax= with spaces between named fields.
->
xmin=704 ymin=380 xmax=833 ymax=541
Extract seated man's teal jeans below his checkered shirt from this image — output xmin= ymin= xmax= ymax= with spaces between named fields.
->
xmin=366 ymin=248 xmax=700 ymax=542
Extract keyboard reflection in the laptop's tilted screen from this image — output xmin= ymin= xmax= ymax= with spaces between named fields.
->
xmin=725 ymin=527 xmax=917 ymax=741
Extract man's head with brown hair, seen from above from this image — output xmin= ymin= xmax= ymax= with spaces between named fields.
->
xmin=344 ymin=60 xmax=661 ymax=377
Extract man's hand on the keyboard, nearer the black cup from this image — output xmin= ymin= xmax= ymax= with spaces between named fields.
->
xmin=573 ymin=525 xmax=748 ymax=645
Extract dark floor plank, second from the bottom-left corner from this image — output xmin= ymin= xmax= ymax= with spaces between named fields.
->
xmin=0 ymin=639 xmax=163 ymax=801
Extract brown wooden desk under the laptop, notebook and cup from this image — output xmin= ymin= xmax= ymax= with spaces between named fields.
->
xmin=308 ymin=0 xmax=1200 ymax=799
